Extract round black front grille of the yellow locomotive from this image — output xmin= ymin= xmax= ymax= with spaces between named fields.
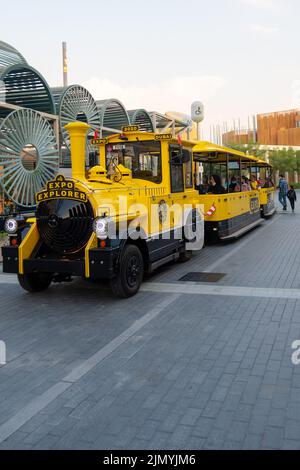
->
xmin=36 ymin=199 xmax=94 ymax=255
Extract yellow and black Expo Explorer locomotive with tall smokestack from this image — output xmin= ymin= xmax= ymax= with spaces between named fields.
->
xmin=3 ymin=122 xmax=204 ymax=297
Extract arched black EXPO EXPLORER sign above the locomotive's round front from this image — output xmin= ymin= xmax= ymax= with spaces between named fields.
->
xmin=35 ymin=175 xmax=87 ymax=204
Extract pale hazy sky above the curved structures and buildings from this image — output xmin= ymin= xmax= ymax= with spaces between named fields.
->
xmin=0 ymin=0 xmax=300 ymax=137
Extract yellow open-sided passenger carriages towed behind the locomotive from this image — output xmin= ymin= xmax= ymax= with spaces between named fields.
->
xmin=193 ymin=142 xmax=275 ymax=240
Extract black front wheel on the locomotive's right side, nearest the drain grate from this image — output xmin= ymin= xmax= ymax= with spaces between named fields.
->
xmin=111 ymin=245 xmax=144 ymax=299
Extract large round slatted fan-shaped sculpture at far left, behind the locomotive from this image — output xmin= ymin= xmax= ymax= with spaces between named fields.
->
xmin=0 ymin=109 xmax=59 ymax=207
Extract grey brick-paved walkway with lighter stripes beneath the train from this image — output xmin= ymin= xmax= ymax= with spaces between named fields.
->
xmin=0 ymin=205 xmax=300 ymax=449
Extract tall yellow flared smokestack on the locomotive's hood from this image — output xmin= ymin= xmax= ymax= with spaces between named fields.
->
xmin=65 ymin=121 xmax=90 ymax=181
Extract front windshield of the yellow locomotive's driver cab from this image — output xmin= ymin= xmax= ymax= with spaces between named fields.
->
xmin=106 ymin=141 xmax=162 ymax=184
